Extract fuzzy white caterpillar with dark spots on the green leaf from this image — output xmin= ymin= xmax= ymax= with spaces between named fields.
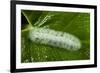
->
xmin=29 ymin=27 xmax=81 ymax=50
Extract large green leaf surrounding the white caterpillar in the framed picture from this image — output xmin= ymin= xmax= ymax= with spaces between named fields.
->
xmin=21 ymin=10 xmax=90 ymax=63
